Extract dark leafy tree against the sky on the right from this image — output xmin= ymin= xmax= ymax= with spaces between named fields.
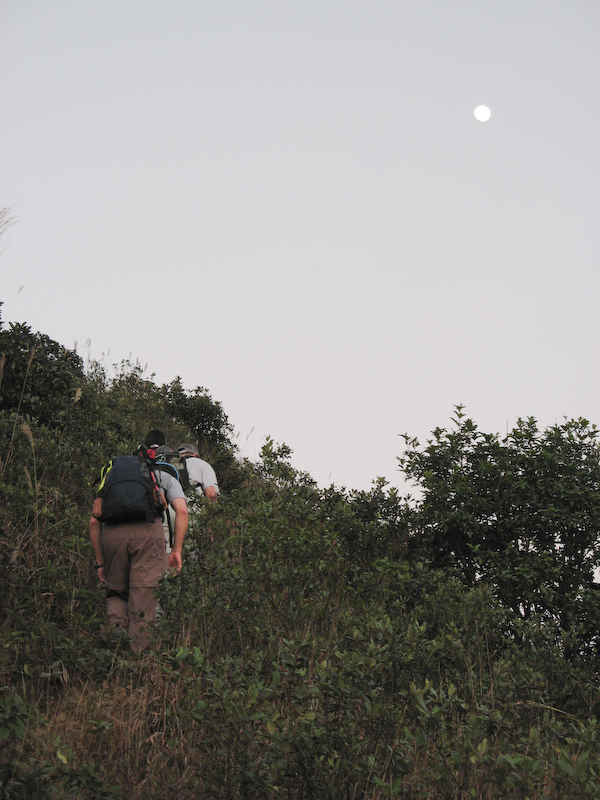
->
xmin=401 ymin=408 xmax=600 ymax=657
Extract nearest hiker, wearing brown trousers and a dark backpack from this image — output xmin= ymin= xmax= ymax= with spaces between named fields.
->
xmin=89 ymin=440 xmax=188 ymax=653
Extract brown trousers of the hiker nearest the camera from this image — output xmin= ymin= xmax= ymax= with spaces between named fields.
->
xmin=101 ymin=518 xmax=168 ymax=653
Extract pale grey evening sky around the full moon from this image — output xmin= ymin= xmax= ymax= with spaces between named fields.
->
xmin=0 ymin=0 xmax=600 ymax=490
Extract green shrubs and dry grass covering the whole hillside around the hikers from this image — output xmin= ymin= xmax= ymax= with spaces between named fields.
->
xmin=0 ymin=316 xmax=600 ymax=800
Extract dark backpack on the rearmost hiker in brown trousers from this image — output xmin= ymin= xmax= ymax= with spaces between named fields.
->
xmin=92 ymin=453 xmax=167 ymax=525
